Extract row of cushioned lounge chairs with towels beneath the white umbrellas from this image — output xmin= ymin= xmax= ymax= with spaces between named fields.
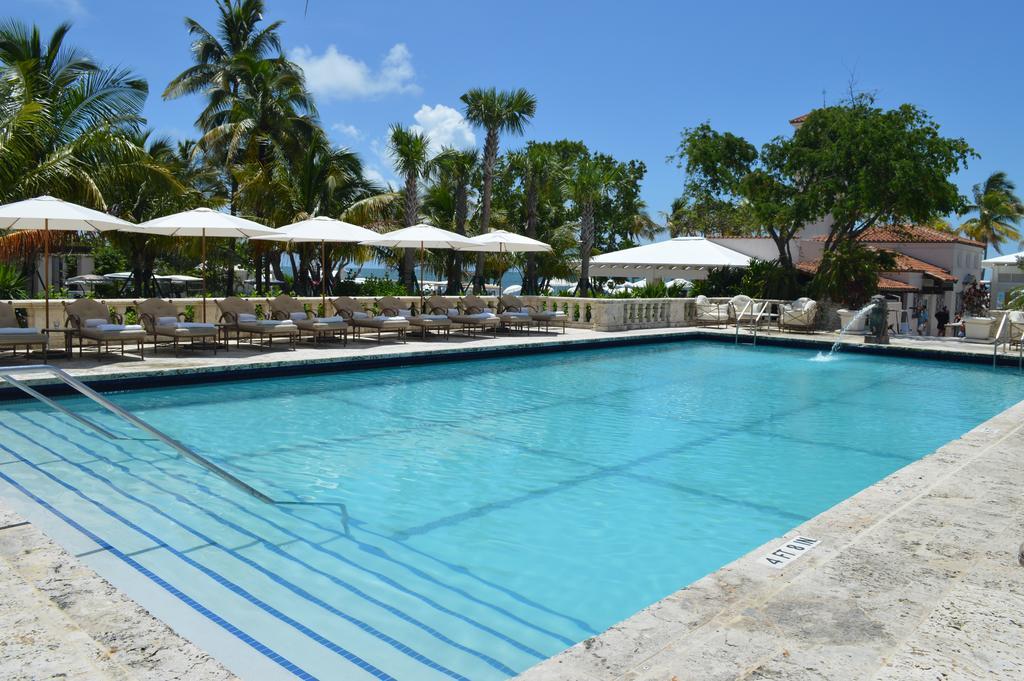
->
xmin=0 ymin=295 xmax=567 ymax=357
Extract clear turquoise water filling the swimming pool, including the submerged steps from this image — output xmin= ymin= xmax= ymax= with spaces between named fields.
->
xmin=0 ymin=342 xmax=1024 ymax=680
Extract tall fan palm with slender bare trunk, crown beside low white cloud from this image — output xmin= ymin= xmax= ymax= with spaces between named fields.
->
xmin=460 ymin=87 xmax=537 ymax=293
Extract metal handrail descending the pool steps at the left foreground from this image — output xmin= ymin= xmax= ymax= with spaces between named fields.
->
xmin=0 ymin=365 xmax=348 ymax=535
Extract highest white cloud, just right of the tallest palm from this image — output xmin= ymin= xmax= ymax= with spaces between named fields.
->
xmin=288 ymin=43 xmax=420 ymax=99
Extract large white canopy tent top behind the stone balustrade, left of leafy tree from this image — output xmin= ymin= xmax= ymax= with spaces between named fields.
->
xmin=590 ymin=237 xmax=751 ymax=281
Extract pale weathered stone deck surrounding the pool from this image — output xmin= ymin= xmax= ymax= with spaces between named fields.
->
xmin=0 ymin=328 xmax=1024 ymax=681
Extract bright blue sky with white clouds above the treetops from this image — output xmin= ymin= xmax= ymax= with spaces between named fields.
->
xmin=8 ymin=0 xmax=1024 ymax=246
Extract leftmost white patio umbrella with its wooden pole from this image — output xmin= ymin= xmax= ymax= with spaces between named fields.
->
xmin=0 ymin=197 xmax=135 ymax=328
